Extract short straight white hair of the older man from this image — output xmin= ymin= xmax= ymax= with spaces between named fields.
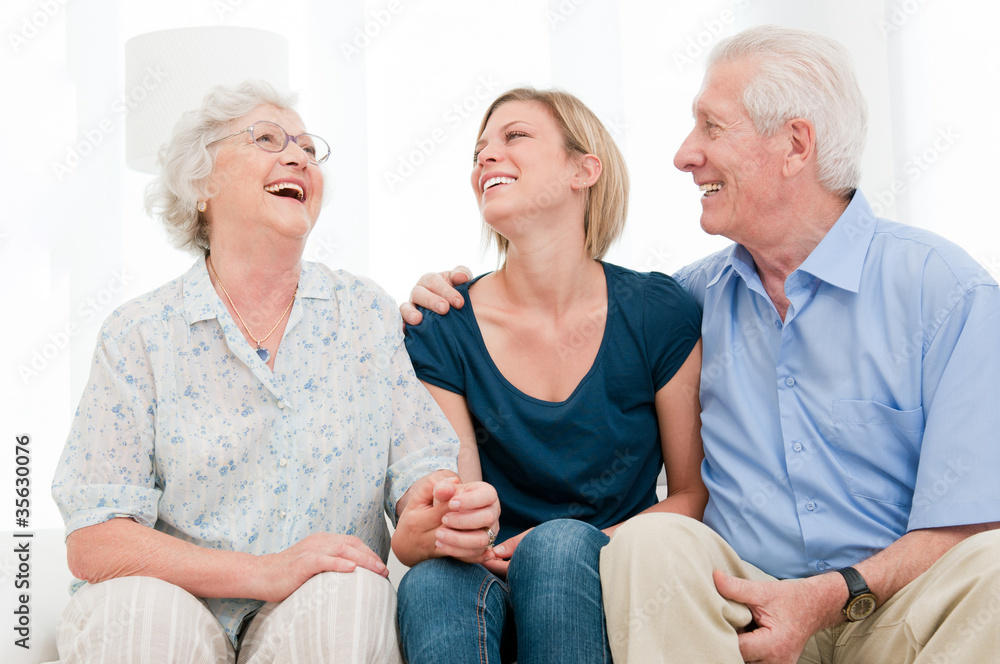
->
xmin=708 ymin=25 xmax=868 ymax=197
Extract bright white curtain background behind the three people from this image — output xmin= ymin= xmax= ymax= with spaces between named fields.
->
xmin=0 ymin=0 xmax=1000 ymax=527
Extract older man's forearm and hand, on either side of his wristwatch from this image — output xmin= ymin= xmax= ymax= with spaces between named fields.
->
xmin=715 ymin=523 xmax=1000 ymax=664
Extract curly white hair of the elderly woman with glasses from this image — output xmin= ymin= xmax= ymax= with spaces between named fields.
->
xmin=145 ymin=80 xmax=295 ymax=254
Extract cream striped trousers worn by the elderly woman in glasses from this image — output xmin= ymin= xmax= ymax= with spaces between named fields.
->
xmin=56 ymin=568 xmax=402 ymax=664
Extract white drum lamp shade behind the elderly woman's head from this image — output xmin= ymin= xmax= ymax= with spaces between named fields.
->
xmin=125 ymin=27 xmax=289 ymax=173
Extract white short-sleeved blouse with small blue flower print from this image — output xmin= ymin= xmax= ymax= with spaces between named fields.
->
xmin=53 ymin=258 xmax=458 ymax=645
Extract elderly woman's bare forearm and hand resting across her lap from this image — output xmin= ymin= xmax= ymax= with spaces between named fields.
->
xmin=66 ymin=518 xmax=388 ymax=602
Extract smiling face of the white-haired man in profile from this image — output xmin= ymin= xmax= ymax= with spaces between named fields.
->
xmin=674 ymin=61 xmax=782 ymax=244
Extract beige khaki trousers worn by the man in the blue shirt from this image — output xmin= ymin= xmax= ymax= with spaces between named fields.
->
xmin=601 ymin=514 xmax=1000 ymax=664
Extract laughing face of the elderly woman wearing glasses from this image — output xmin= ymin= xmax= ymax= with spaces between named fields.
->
xmin=205 ymin=105 xmax=323 ymax=242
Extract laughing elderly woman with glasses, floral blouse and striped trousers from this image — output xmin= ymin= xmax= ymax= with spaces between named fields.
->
xmin=53 ymin=82 xmax=499 ymax=664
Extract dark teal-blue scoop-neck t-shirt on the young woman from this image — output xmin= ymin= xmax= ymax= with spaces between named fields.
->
xmin=406 ymin=263 xmax=701 ymax=541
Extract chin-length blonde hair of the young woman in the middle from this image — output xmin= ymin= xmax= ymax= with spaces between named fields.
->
xmin=477 ymin=88 xmax=629 ymax=260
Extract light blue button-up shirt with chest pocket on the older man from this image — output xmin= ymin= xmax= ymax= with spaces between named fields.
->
xmin=675 ymin=192 xmax=1000 ymax=578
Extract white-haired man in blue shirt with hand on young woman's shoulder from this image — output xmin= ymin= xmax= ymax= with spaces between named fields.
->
xmin=404 ymin=26 xmax=1000 ymax=664
